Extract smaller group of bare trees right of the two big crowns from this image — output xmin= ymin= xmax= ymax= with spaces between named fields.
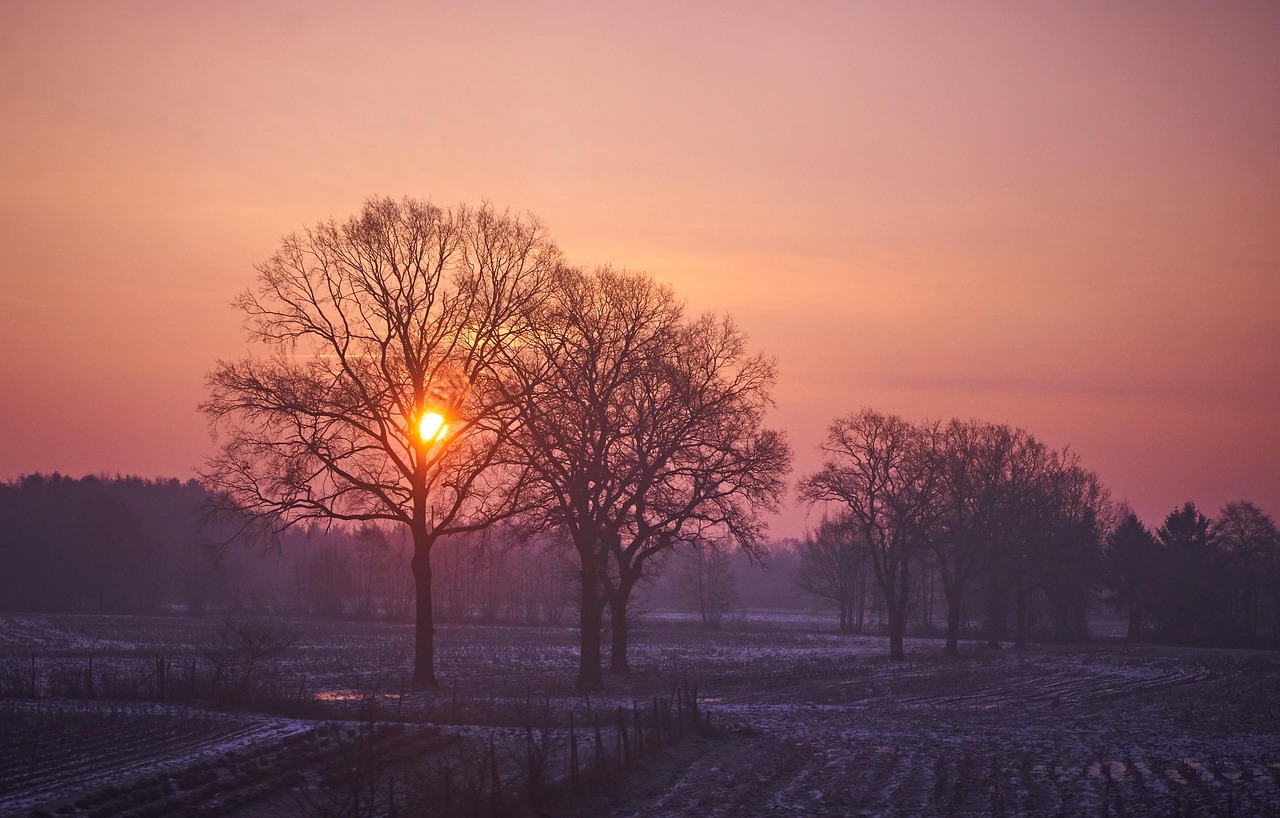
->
xmin=797 ymin=410 xmax=1114 ymax=658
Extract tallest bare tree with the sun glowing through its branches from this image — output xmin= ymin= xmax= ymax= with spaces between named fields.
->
xmin=201 ymin=198 xmax=561 ymax=686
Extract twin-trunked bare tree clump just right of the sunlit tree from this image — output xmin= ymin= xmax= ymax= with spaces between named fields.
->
xmin=501 ymin=269 xmax=790 ymax=690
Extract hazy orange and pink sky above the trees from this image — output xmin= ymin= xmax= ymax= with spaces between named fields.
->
xmin=0 ymin=0 xmax=1280 ymax=536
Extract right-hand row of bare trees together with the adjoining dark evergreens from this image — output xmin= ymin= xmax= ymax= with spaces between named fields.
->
xmin=796 ymin=410 xmax=1280 ymax=658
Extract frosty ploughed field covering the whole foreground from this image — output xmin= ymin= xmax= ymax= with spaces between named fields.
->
xmin=0 ymin=614 xmax=1280 ymax=818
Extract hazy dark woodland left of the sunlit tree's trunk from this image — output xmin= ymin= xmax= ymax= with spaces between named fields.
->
xmin=0 ymin=474 xmax=413 ymax=617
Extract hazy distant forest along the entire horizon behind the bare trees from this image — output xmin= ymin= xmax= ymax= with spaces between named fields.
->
xmin=0 ymin=474 xmax=1280 ymax=646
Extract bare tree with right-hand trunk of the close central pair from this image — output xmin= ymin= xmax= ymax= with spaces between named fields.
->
xmin=602 ymin=309 xmax=791 ymax=673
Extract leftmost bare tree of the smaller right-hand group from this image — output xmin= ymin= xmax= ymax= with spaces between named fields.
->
xmin=800 ymin=410 xmax=941 ymax=659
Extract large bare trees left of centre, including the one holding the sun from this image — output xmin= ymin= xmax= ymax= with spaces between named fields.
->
xmin=202 ymin=200 xmax=791 ymax=690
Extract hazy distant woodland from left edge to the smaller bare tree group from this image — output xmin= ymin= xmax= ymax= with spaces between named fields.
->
xmin=0 ymin=474 xmax=768 ymax=626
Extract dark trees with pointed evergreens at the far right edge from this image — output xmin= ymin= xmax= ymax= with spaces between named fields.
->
xmin=1106 ymin=502 xmax=1280 ymax=645
